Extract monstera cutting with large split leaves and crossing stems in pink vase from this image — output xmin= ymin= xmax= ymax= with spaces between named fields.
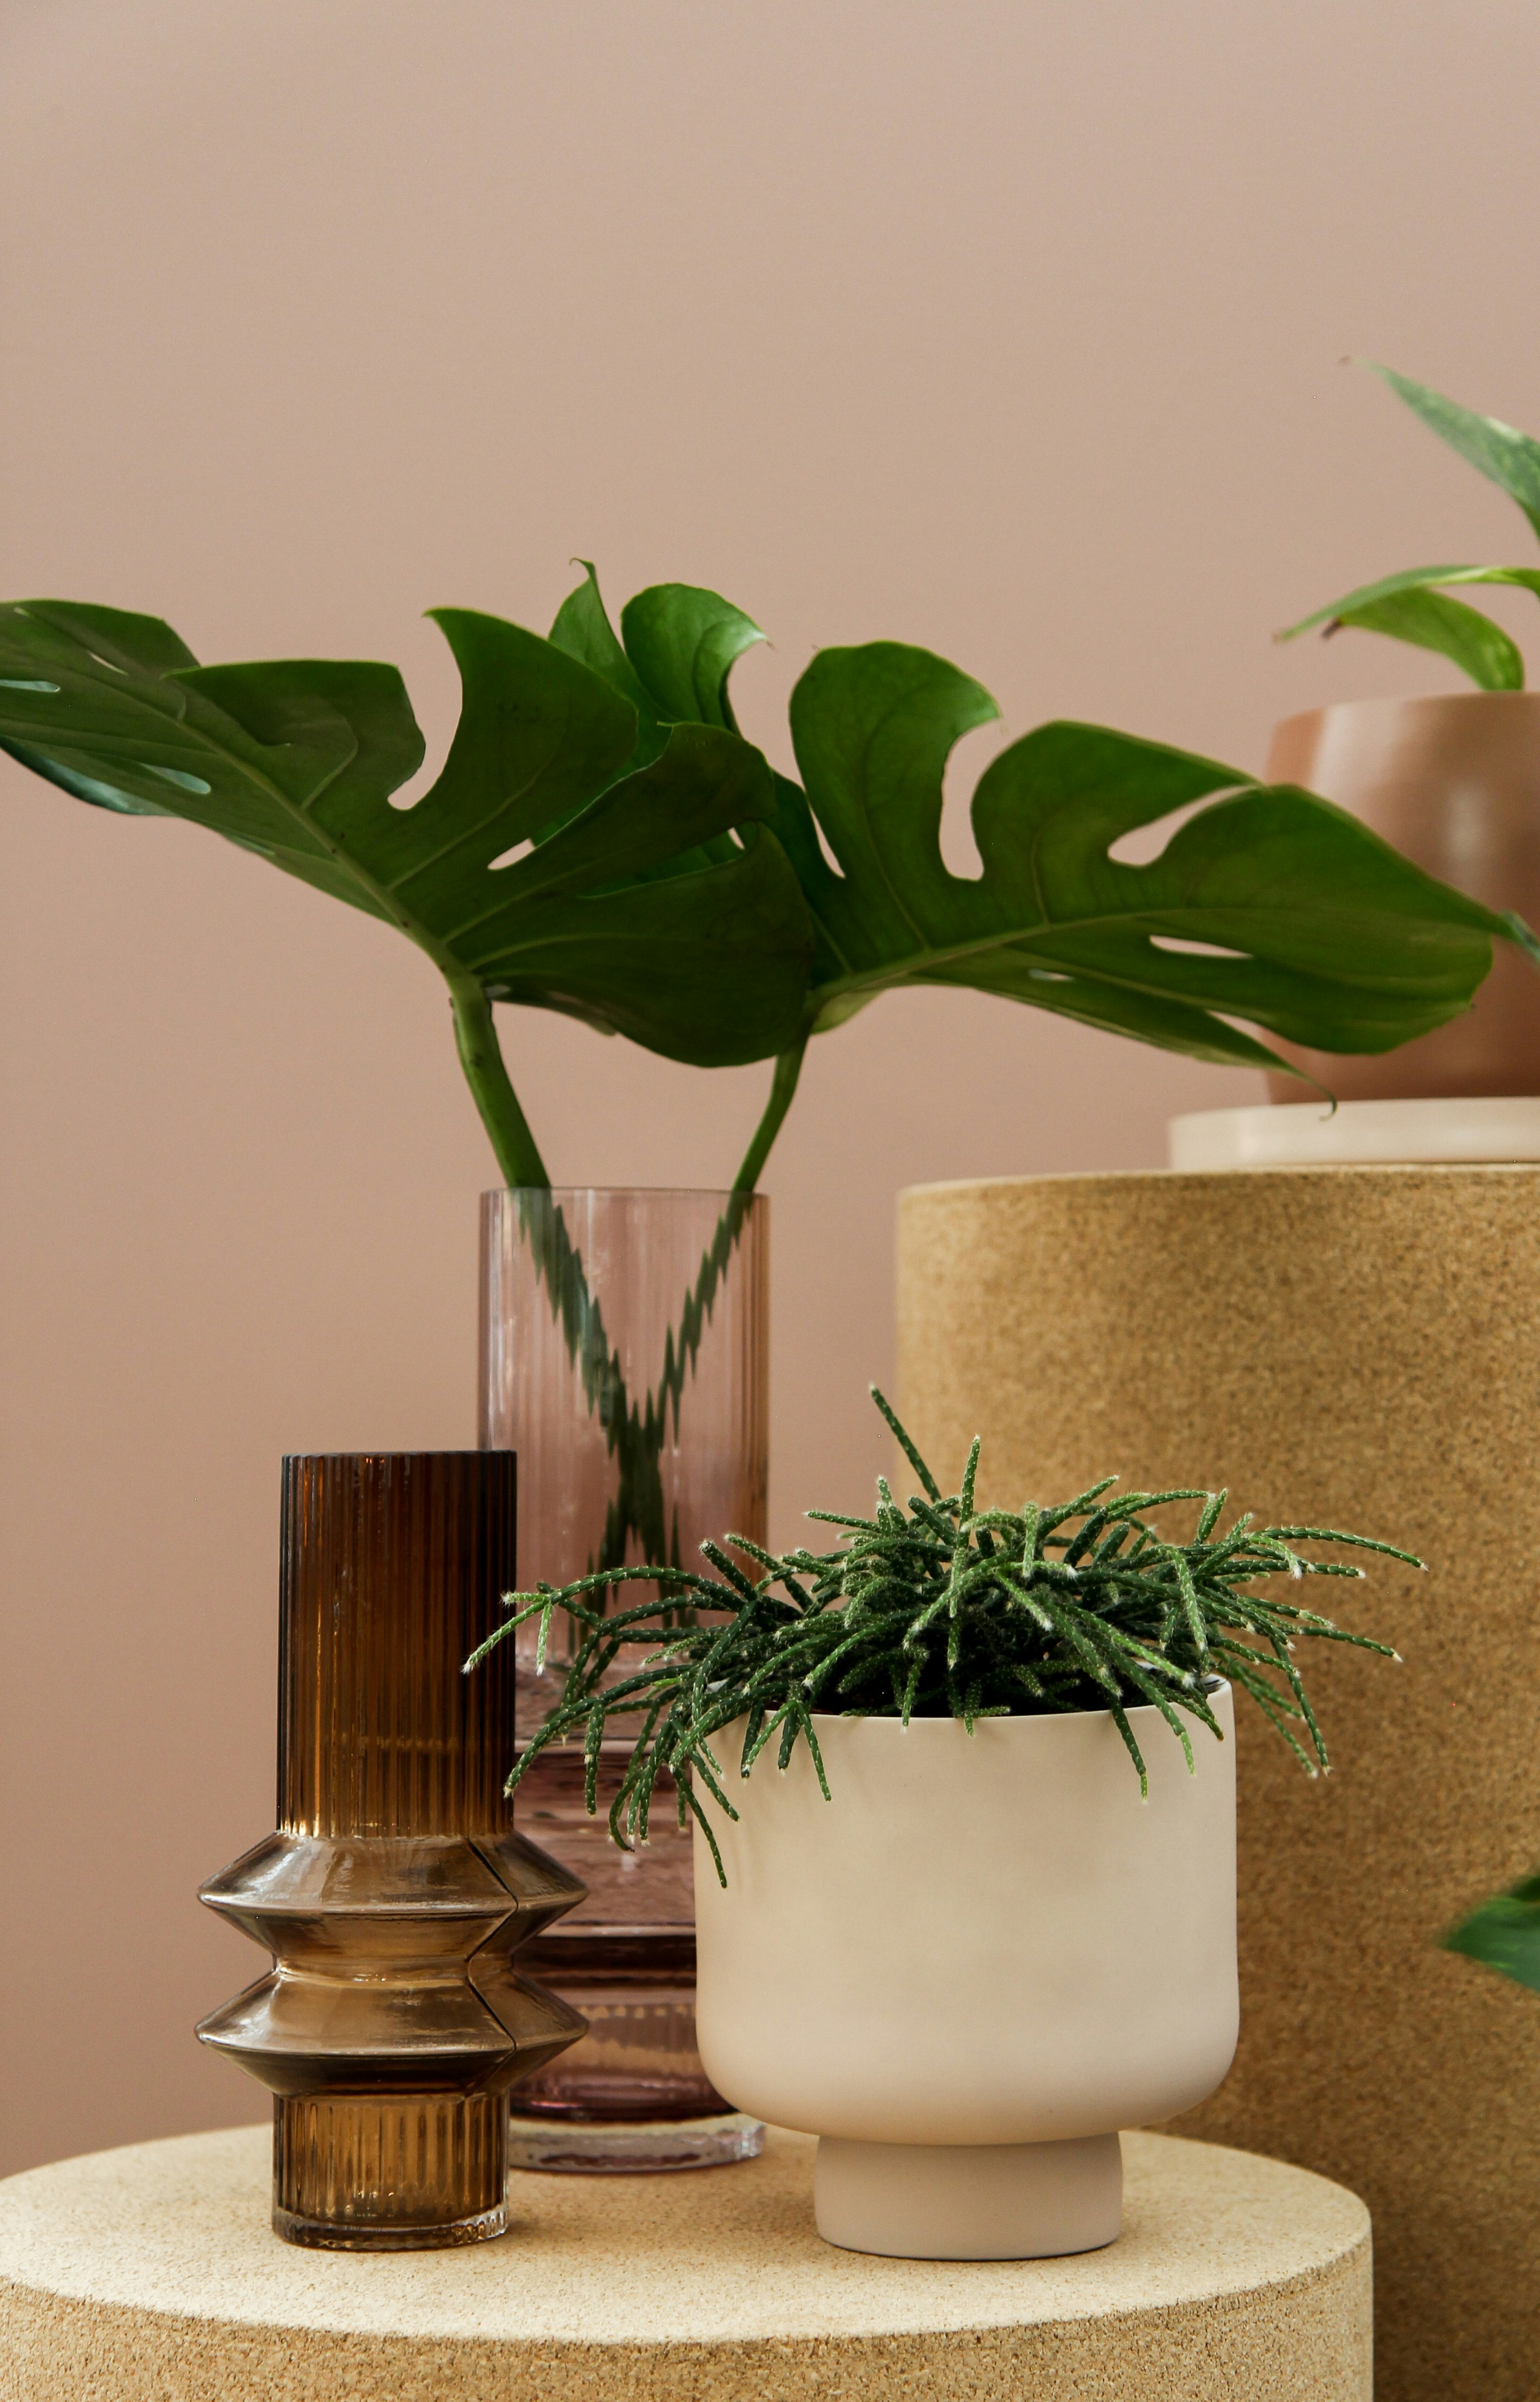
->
xmin=0 ymin=569 xmax=1533 ymax=1571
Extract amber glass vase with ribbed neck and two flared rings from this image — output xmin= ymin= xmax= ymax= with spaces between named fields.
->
xmin=197 ymin=1451 xmax=586 ymax=2251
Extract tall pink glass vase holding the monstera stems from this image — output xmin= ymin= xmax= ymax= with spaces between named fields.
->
xmin=481 ymin=1189 xmax=769 ymax=2172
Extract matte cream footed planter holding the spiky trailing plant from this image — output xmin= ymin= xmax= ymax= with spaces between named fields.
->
xmin=694 ymin=1686 xmax=1240 ymax=2260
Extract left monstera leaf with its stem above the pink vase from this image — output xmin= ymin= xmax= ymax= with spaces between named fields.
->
xmin=0 ymin=601 xmax=812 ymax=1182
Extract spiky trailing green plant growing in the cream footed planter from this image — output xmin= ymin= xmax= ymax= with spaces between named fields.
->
xmin=466 ymin=1386 xmax=1422 ymax=1883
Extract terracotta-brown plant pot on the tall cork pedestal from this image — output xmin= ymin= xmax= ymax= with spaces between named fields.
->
xmin=1266 ymin=692 xmax=1540 ymax=1103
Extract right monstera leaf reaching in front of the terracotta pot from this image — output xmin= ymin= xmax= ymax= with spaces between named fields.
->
xmin=790 ymin=644 xmax=1511 ymax=1066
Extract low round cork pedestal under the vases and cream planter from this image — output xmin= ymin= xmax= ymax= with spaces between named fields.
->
xmin=0 ymin=2128 xmax=1369 ymax=2402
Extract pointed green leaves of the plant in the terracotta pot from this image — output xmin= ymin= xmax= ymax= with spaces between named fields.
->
xmin=1278 ymin=368 xmax=1540 ymax=692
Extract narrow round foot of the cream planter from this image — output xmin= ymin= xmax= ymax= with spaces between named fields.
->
xmin=812 ymin=2135 xmax=1122 ymax=2260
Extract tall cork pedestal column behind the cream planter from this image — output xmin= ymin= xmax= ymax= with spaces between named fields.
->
xmin=899 ymin=1167 xmax=1540 ymax=2402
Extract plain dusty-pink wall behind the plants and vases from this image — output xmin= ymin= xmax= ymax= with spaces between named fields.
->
xmin=0 ymin=0 xmax=1540 ymax=2167
